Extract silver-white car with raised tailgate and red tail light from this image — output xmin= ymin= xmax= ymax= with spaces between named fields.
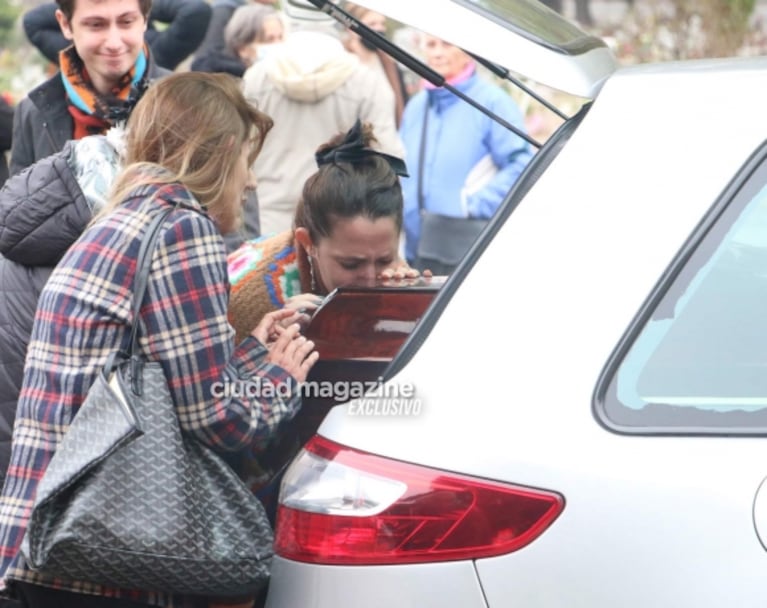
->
xmin=267 ymin=0 xmax=767 ymax=608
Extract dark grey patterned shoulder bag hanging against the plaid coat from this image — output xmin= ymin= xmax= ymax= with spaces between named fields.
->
xmin=22 ymin=209 xmax=273 ymax=596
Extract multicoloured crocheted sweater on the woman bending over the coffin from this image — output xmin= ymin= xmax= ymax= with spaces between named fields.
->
xmin=227 ymin=230 xmax=311 ymax=344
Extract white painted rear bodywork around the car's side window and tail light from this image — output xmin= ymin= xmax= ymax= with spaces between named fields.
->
xmin=269 ymin=54 xmax=767 ymax=608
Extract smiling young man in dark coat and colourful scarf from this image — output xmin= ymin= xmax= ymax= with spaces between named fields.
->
xmin=10 ymin=0 xmax=169 ymax=174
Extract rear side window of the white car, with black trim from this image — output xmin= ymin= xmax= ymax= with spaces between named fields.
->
xmin=596 ymin=147 xmax=767 ymax=434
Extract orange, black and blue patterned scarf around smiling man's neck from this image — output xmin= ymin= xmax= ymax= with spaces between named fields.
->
xmin=59 ymin=46 xmax=149 ymax=139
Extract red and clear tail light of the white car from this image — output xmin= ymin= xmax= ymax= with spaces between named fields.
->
xmin=275 ymin=436 xmax=564 ymax=565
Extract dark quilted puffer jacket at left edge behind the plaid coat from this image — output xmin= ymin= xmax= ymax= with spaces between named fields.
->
xmin=0 ymin=141 xmax=102 ymax=481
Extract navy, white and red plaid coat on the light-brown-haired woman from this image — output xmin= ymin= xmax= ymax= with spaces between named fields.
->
xmin=0 ymin=178 xmax=300 ymax=606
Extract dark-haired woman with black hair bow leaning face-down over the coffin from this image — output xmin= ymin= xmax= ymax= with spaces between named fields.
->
xmin=228 ymin=121 xmax=418 ymax=336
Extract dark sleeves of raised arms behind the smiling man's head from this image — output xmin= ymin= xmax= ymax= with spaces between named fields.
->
xmin=22 ymin=0 xmax=211 ymax=70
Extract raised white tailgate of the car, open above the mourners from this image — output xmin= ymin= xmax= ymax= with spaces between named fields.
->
xmin=318 ymin=0 xmax=618 ymax=99
